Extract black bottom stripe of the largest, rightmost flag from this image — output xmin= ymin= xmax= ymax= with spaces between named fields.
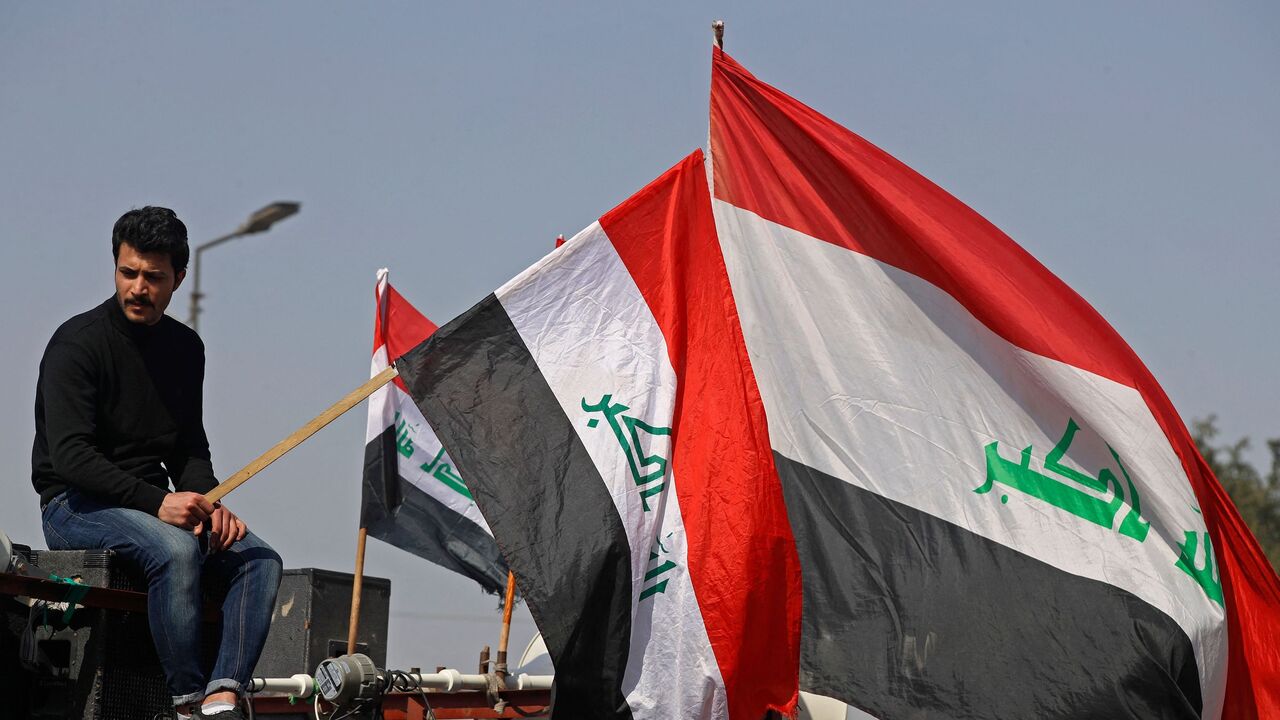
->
xmin=774 ymin=452 xmax=1202 ymax=720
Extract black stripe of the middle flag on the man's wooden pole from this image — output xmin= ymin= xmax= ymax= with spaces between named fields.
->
xmin=396 ymin=295 xmax=631 ymax=719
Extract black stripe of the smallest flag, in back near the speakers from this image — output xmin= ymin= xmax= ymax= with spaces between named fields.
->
xmin=360 ymin=427 xmax=507 ymax=593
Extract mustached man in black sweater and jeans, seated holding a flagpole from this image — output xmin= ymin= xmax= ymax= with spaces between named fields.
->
xmin=32 ymin=208 xmax=280 ymax=720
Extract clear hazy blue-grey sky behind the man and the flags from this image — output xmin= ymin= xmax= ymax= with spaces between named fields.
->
xmin=0 ymin=0 xmax=1280 ymax=667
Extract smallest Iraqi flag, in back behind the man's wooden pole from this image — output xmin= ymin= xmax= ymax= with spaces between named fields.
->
xmin=360 ymin=269 xmax=507 ymax=593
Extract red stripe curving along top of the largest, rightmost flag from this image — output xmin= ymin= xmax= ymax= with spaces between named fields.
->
xmin=710 ymin=49 xmax=1280 ymax=717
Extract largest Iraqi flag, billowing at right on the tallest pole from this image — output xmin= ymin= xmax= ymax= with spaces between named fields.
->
xmin=710 ymin=50 xmax=1280 ymax=719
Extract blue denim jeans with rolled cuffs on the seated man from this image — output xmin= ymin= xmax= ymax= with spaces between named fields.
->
xmin=42 ymin=491 xmax=282 ymax=705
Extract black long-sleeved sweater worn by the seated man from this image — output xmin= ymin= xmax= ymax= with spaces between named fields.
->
xmin=31 ymin=296 xmax=218 ymax=515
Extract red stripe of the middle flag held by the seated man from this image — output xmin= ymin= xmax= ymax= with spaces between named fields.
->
xmin=600 ymin=151 xmax=801 ymax=720
